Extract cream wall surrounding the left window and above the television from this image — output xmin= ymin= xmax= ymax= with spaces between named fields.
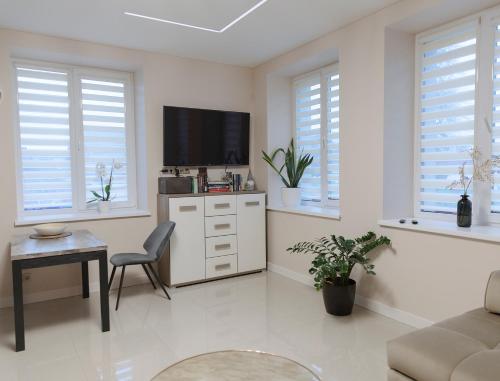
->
xmin=0 ymin=29 xmax=252 ymax=305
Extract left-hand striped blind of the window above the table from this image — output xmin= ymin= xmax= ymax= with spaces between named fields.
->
xmin=16 ymin=65 xmax=73 ymax=211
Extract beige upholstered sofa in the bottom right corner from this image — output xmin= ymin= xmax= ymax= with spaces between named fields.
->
xmin=387 ymin=271 xmax=500 ymax=381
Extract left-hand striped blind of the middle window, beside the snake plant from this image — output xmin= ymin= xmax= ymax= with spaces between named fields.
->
xmin=294 ymin=73 xmax=322 ymax=202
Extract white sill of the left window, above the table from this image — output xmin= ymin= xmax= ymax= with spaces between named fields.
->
xmin=14 ymin=209 xmax=151 ymax=226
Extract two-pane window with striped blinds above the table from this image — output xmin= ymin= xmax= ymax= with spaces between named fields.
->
xmin=14 ymin=61 xmax=137 ymax=217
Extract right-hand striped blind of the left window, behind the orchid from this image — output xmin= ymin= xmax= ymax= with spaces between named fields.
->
xmin=80 ymin=77 xmax=128 ymax=202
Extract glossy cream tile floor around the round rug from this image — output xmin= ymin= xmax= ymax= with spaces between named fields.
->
xmin=0 ymin=272 xmax=411 ymax=381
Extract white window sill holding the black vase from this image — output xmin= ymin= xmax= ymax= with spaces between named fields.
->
xmin=378 ymin=218 xmax=500 ymax=243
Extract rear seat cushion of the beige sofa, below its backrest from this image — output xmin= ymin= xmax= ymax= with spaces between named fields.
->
xmin=435 ymin=308 xmax=500 ymax=349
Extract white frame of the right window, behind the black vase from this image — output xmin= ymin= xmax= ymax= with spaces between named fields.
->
xmin=413 ymin=12 xmax=500 ymax=223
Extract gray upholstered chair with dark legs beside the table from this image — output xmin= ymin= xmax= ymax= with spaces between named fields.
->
xmin=108 ymin=221 xmax=175 ymax=310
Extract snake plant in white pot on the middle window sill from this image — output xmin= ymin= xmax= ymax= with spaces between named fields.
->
xmin=262 ymin=139 xmax=313 ymax=207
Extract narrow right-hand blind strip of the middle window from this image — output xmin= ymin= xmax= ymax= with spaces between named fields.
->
xmin=326 ymin=70 xmax=340 ymax=200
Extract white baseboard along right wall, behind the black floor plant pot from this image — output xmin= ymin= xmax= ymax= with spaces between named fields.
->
xmin=267 ymin=262 xmax=434 ymax=328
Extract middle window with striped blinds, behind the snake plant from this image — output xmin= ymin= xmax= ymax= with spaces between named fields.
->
xmin=294 ymin=65 xmax=340 ymax=206
